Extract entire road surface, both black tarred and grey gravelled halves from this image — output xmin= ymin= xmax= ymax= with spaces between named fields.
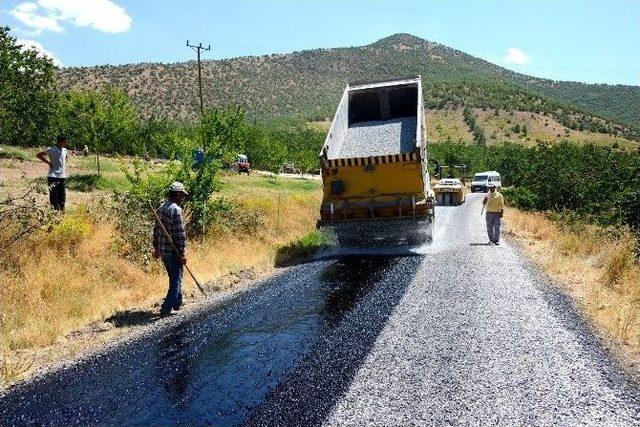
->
xmin=0 ymin=195 xmax=640 ymax=426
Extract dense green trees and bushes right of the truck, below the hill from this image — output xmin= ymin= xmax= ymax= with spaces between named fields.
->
xmin=429 ymin=141 xmax=640 ymax=230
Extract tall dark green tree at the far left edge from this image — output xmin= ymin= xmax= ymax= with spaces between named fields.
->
xmin=0 ymin=27 xmax=56 ymax=146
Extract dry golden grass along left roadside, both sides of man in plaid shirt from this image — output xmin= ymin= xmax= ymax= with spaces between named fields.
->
xmin=0 ymin=172 xmax=321 ymax=383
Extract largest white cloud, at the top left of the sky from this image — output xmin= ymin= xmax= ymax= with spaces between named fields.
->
xmin=9 ymin=0 xmax=131 ymax=33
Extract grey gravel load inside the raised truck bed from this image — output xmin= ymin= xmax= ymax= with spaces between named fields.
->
xmin=338 ymin=117 xmax=418 ymax=159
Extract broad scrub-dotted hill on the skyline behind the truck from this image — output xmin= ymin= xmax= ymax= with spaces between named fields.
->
xmin=58 ymin=34 xmax=640 ymax=140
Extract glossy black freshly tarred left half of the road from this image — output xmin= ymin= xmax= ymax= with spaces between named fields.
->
xmin=0 ymin=256 xmax=422 ymax=425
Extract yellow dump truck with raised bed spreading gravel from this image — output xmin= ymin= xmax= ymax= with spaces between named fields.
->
xmin=318 ymin=76 xmax=434 ymax=244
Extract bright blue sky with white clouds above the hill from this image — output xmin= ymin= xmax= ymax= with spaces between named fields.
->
xmin=0 ymin=0 xmax=640 ymax=85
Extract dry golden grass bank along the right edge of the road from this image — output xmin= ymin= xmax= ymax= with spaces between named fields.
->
xmin=506 ymin=209 xmax=640 ymax=358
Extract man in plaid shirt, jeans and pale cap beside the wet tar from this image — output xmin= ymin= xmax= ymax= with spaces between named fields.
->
xmin=153 ymin=181 xmax=188 ymax=316
